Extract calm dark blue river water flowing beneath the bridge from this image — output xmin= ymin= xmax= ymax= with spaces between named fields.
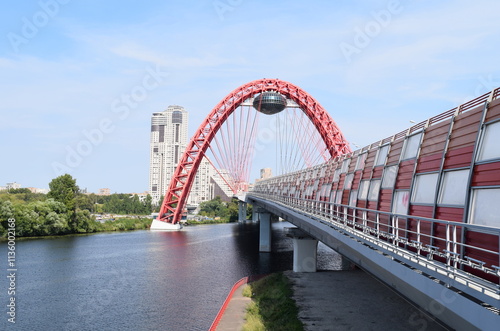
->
xmin=0 ymin=222 xmax=338 ymax=331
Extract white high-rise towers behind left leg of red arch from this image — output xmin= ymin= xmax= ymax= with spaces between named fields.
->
xmin=149 ymin=106 xmax=231 ymax=209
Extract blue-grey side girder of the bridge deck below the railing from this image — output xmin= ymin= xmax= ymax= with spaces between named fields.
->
xmin=244 ymin=192 xmax=500 ymax=330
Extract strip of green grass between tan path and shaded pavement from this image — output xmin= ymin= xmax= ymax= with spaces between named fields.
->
xmin=243 ymin=273 xmax=304 ymax=331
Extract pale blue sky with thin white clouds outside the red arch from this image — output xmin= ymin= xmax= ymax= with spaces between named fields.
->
xmin=0 ymin=0 xmax=500 ymax=193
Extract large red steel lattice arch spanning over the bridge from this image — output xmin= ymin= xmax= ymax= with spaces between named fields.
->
xmin=158 ymin=79 xmax=351 ymax=224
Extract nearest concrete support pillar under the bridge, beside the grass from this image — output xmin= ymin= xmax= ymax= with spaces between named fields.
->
xmin=285 ymin=228 xmax=318 ymax=272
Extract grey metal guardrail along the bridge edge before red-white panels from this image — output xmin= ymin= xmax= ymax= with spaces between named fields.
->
xmin=247 ymin=192 xmax=500 ymax=313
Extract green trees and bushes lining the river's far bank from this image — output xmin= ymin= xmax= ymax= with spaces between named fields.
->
xmin=0 ymin=174 xmax=245 ymax=241
